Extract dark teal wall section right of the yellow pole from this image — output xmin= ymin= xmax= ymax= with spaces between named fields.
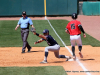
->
xmin=47 ymin=0 xmax=78 ymax=15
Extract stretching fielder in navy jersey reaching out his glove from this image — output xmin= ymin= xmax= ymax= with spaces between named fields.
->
xmin=31 ymin=28 xmax=71 ymax=63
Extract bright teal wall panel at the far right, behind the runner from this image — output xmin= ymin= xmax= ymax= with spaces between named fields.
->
xmin=82 ymin=2 xmax=100 ymax=15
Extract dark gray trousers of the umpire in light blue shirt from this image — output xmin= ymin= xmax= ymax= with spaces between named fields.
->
xmin=21 ymin=29 xmax=31 ymax=51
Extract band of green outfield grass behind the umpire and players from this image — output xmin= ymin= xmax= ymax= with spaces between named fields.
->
xmin=0 ymin=20 xmax=100 ymax=47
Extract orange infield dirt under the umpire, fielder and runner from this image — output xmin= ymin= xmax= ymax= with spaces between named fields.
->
xmin=0 ymin=46 xmax=100 ymax=75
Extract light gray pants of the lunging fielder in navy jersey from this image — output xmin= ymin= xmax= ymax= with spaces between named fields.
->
xmin=45 ymin=44 xmax=60 ymax=58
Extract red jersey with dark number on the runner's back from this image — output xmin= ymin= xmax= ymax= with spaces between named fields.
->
xmin=66 ymin=20 xmax=81 ymax=35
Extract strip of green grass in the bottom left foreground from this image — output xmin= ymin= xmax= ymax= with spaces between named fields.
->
xmin=0 ymin=66 xmax=67 ymax=75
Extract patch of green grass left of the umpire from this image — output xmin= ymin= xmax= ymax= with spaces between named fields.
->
xmin=0 ymin=21 xmax=22 ymax=47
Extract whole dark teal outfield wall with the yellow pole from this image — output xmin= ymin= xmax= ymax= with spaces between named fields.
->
xmin=0 ymin=0 xmax=78 ymax=16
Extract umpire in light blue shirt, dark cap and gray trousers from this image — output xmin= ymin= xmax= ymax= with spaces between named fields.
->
xmin=15 ymin=11 xmax=34 ymax=53
